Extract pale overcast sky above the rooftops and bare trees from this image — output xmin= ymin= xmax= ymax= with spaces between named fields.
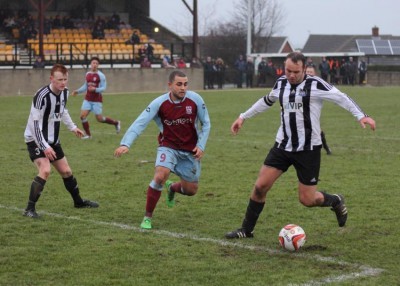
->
xmin=150 ymin=0 xmax=400 ymax=48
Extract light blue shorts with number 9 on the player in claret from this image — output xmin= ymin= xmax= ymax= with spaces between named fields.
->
xmin=155 ymin=147 xmax=201 ymax=183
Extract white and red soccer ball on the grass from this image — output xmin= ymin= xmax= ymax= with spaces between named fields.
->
xmin=279 ymin=224 xmax=306 ymax=251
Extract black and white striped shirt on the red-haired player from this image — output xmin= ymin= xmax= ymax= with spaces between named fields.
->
xmin=24 ymin=85 xmax=77 ymax=150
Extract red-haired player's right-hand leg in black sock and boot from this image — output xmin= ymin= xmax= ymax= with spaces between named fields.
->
xmin=52 ymin=145 xmax=99 ymax=208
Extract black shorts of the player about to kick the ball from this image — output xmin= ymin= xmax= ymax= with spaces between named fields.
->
xmin=264 ymin=146 xmax=321 ymax=186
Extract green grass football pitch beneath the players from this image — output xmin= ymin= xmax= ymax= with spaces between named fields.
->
xmin=0 ymin=87 xmax=400 ymax=285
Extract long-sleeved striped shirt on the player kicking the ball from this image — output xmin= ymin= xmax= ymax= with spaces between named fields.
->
xmin=240 ymin=75 xmax=367 ymax=152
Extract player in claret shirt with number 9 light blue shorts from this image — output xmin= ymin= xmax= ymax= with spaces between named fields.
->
xmin=114 ymin=71 xmax=211 ymax=229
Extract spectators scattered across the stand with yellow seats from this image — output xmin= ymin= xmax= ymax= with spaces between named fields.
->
xmin=0 ymin=4 xmax=191 ymax=68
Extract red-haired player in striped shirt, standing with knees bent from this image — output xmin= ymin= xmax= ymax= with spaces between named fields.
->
xmin=23 ymin=64 xmax=99 ymax=218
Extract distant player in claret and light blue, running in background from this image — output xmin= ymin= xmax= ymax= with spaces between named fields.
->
xmin=71 ymin=57 xmax=121 ymax=139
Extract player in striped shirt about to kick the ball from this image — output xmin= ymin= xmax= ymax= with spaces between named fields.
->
xmin=225 ymin=52 xmax=375 ymax=238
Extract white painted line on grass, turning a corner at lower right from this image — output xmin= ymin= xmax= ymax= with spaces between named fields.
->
xmin=0 ymin=204 xmax=384 ymax=286
